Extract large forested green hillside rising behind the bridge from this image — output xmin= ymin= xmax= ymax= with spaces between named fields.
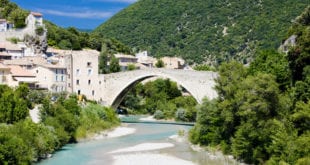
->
xmin=94 ymin=0 xmax=310 ymax=63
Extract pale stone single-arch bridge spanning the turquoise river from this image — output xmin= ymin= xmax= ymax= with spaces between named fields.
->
xmin=100 ymin=68 xmax=217 ymax=108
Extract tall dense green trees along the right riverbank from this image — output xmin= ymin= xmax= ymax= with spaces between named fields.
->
xmin=190 ymin=7 xmax=310 ymax=165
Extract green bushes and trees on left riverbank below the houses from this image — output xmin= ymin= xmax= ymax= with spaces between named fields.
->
xmin=0 ymin=85 xmax=119 ymax=164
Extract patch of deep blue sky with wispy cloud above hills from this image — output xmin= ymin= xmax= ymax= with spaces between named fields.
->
xmin=11 ymin=0 xmax=137 ymax=29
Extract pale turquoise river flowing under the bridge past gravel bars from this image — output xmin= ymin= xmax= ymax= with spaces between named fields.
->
xmin=37 ymin=123 xmax=239 ymax=165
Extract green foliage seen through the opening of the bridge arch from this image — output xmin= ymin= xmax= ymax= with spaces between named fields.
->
xmin=121 ymin=79 xmax=197 ymax=121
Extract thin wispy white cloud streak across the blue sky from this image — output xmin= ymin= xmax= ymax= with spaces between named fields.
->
xmin=38 ymin=9 xmax=114 ymax=19
